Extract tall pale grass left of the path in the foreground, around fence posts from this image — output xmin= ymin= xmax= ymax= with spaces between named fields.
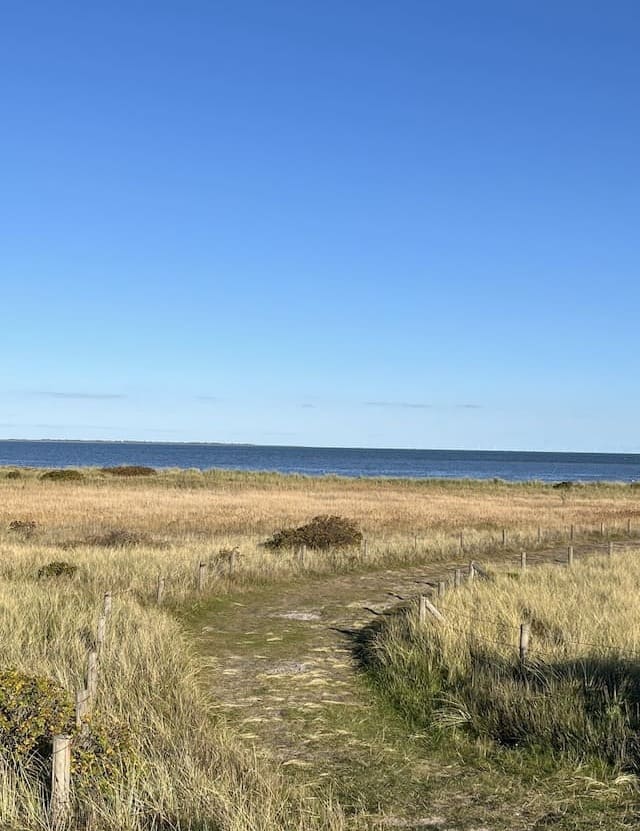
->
xmin=0 ymin=579 xmax=341 ymax=831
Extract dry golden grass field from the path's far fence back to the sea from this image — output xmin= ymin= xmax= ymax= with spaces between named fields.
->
xmin=0 ymin=470 xmax=640 ymax=602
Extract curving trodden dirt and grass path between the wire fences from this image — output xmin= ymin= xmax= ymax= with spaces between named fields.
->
xmin=192 ymin=544 xmax=624 ymax=831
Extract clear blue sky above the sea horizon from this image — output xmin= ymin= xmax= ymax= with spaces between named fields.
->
xmin=0 ymin=0 xmax=640 ymax=451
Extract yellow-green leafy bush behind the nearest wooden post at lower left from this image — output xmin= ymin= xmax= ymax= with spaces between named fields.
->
xmin=0 ymin=669 xmax=74 ymax=763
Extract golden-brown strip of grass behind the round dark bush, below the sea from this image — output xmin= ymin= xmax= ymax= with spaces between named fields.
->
xmin=0 ymin=471 xmax=640 ymax=538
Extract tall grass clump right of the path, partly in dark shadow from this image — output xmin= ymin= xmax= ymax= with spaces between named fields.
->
xmin=364 ymin=549 xmax=640 ymax=773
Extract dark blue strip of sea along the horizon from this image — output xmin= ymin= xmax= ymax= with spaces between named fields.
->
xmin=0 ymin=441 xmax=640 ymax=482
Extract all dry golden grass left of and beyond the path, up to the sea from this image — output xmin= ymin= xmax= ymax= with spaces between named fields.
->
xmin=0 ymin=470 xmax=640 ymax=831
